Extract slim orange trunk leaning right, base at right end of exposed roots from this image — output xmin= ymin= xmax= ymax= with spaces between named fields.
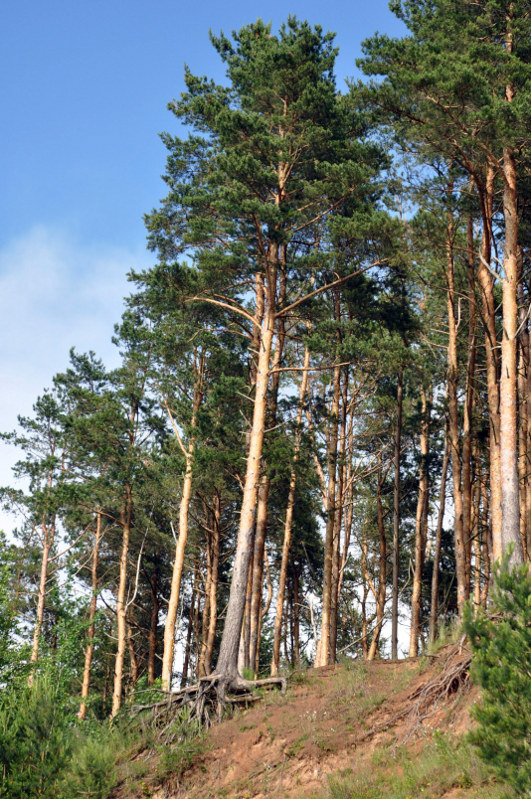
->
xmin=271 ymin=347 xmax=310 ymax=676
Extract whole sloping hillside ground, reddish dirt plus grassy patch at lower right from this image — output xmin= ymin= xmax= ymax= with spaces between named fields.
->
xmin=113 ymin=644 xmax=508 ymax=799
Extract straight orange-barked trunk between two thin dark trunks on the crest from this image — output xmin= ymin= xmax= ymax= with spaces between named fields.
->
xmin=409 ymin=383 xmax=429 ymax=657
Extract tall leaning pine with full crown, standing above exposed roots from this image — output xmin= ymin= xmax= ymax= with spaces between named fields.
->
xmin=147 ymin=18 xmax=381 ymax=684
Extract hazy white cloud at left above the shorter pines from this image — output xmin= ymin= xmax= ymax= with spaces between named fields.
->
xmin=0 ymin=227 xmax=149 ymax=529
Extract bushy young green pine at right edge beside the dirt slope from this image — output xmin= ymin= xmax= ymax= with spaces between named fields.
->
xmin=464 ymin=555 xmax=531 ymax=796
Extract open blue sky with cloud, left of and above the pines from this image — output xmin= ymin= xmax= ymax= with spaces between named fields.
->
xmin=0 ymin=0 xmax=403 ymax=510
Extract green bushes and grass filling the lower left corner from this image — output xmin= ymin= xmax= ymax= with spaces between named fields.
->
xmin=0 ymin=671 xmax=204 ymax=799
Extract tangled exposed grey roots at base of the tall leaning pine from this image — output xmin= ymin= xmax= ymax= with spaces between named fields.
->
xmin=129 ymin=674 xmax=286 ymax=743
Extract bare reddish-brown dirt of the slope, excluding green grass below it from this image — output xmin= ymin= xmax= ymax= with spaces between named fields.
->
xmin=120 ymin=645 xmax=486 ymax=799
